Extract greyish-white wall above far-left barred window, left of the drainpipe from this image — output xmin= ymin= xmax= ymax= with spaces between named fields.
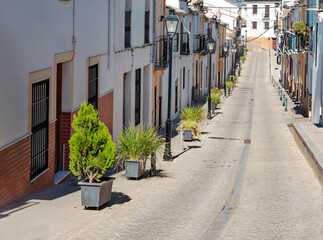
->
xmin=0 ymin=0 xmax=73 ymax=149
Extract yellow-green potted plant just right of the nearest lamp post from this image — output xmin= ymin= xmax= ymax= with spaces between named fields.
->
xmin=177 ymin=106 xmax=204 ymax=141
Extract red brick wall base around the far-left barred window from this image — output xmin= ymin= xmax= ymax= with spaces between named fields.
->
xmin=0 ymin=122 xmax=56 ymax=207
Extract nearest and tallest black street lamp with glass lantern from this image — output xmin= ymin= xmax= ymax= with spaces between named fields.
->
xmin=163 ymin=15 xmax=179 ymax=161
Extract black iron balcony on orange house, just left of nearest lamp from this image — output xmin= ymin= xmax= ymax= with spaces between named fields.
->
xmin=154 ymin=36 xmax=169 ymax=69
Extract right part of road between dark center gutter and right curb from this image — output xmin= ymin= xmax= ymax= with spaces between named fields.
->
xmin=204 ymin=49 xmax=323 ymax=239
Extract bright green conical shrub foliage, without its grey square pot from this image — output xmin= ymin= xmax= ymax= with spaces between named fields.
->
xmin=69 ymin=102 xmax=115 ymax=183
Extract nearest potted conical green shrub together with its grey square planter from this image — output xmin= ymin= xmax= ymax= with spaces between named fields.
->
xmin=69 ymin=102 xmax=115 ymax=208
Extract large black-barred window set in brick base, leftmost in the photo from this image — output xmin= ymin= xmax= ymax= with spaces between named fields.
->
xmin=30 ymin=79 xmax=49 ymax=180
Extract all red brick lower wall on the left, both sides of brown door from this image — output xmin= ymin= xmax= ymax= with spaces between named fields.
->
xmin=0 ymin=91 xmax=113 ymax=207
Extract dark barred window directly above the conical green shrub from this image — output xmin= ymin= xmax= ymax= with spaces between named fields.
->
xmin=88 ymin=64 xmax=99 ymax=109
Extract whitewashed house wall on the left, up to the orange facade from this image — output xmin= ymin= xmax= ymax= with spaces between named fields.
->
xmin=0 ymin=0 xmax=153 ymax=149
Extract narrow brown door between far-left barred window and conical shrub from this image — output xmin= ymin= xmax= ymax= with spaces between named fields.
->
xmin=55 ymin=63 xmax=63 ymax=172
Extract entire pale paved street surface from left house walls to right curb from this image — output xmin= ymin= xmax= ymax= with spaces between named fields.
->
xmin=0 ymin=47 xmax=323 ymax=239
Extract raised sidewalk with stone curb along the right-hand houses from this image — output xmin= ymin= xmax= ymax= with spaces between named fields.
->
xmin=271 ymin=47 xmax=323 ymax=185
